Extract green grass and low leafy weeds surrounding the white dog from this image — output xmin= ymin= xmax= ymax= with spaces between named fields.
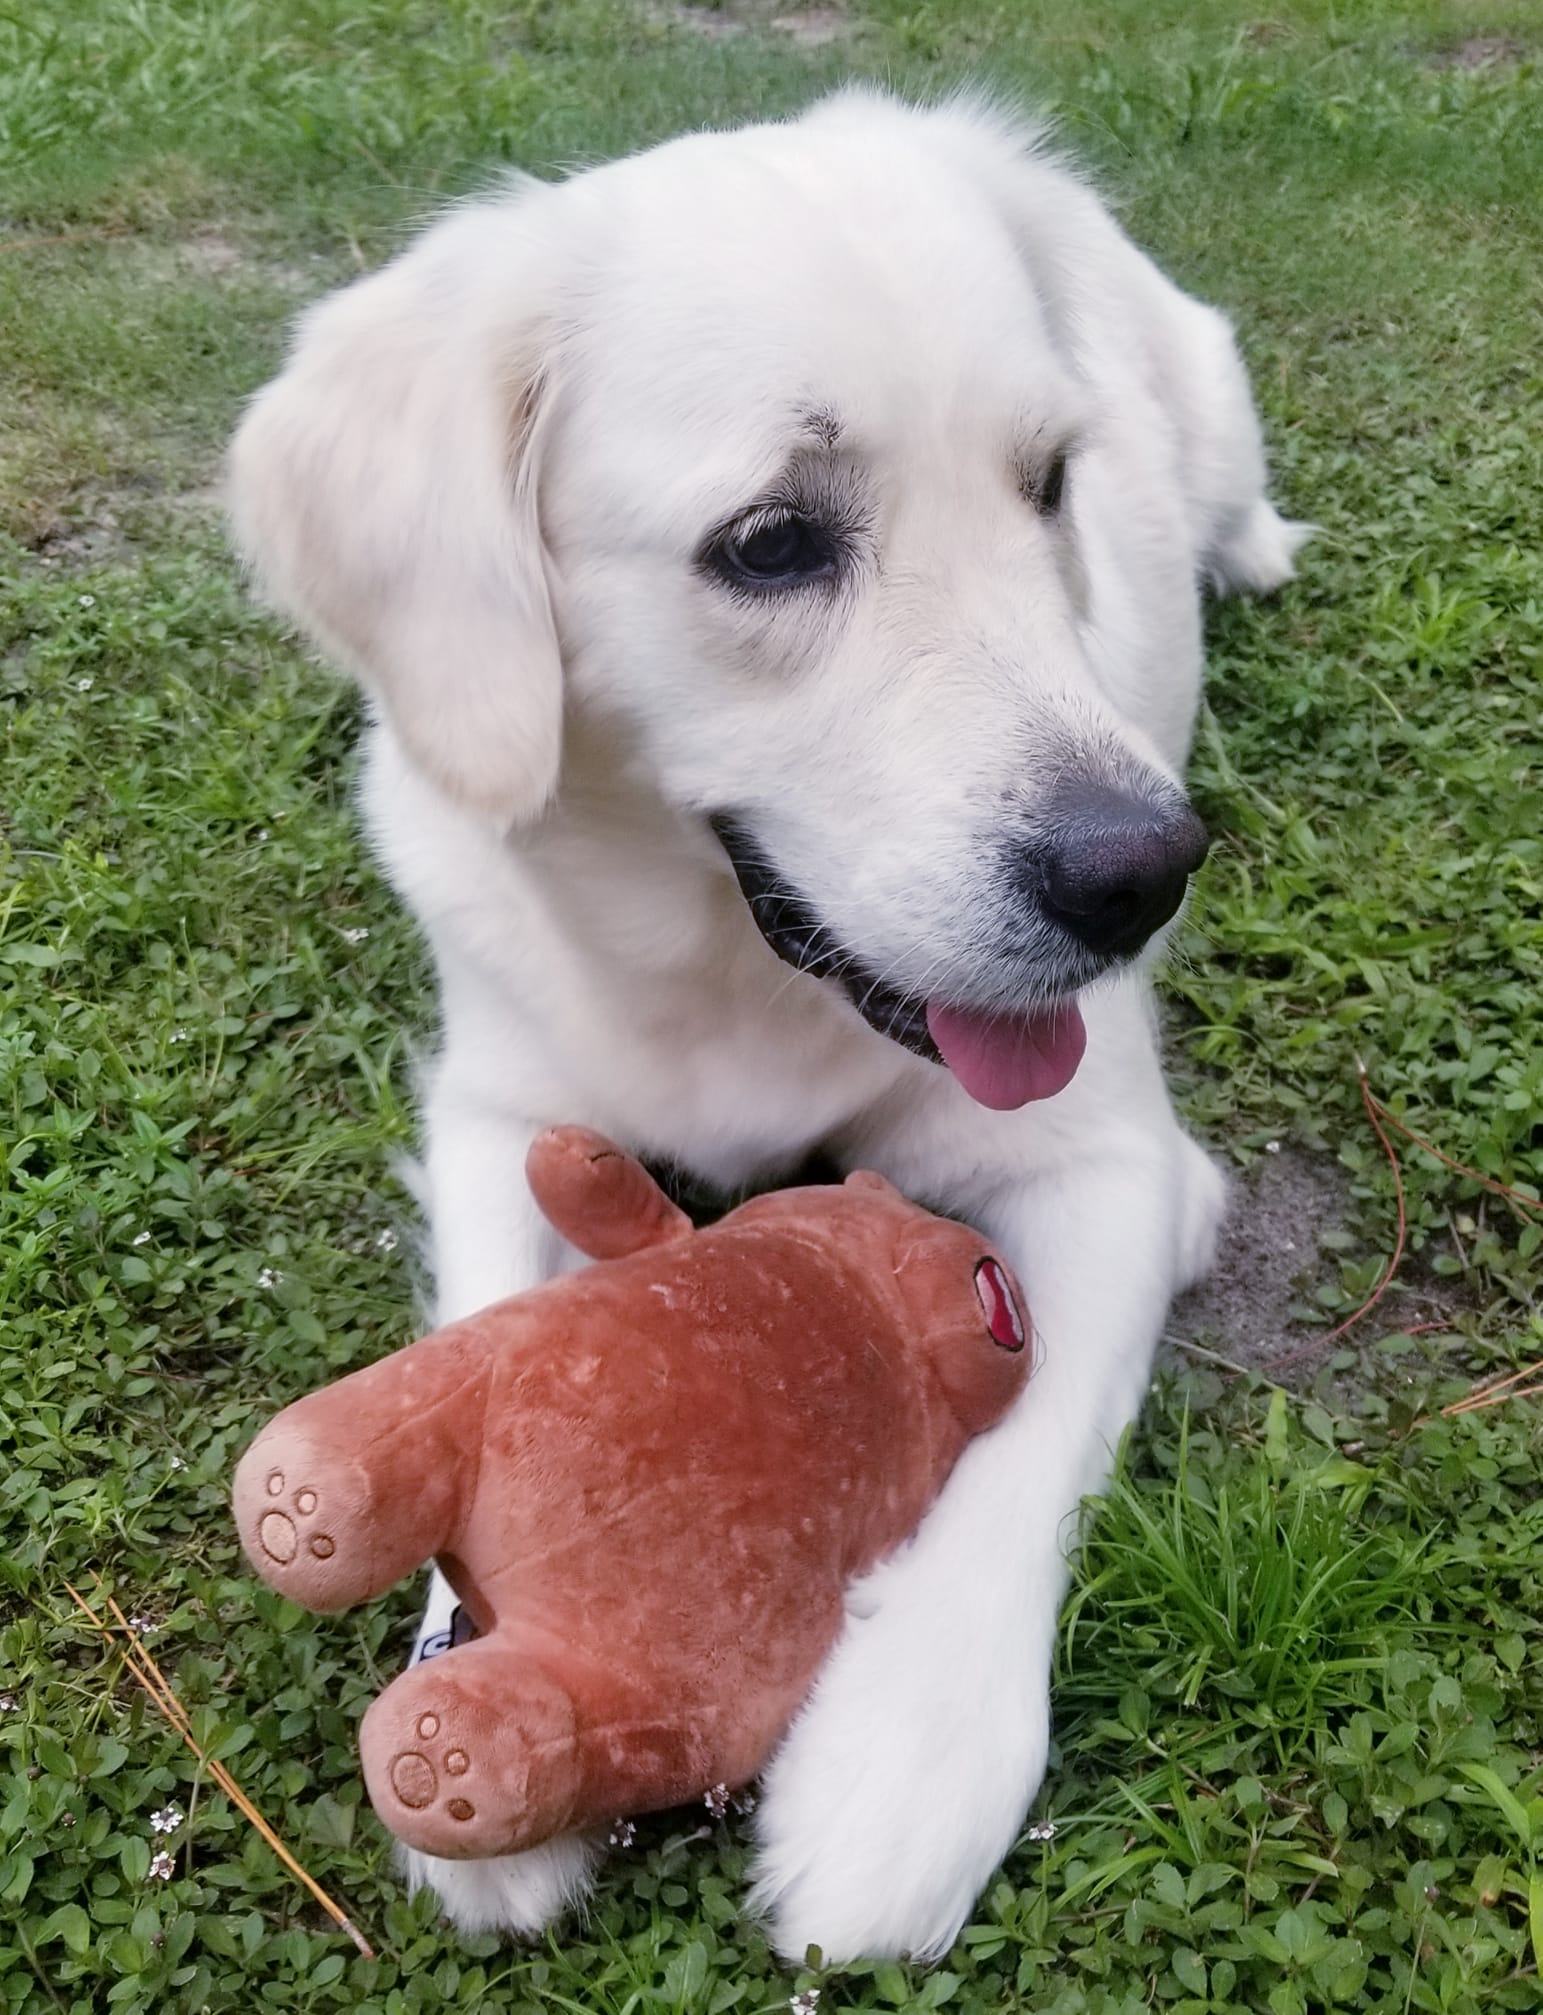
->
xmin=0 ymin=0 xmax=1543 ymax=2015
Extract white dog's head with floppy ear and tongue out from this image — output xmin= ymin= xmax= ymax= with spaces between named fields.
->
xmin=234 ymin=93 xmax=1205 ymax=1104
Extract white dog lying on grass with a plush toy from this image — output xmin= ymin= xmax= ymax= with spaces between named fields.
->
xmin=234 ymin=91 xmax=1299 ymax=1959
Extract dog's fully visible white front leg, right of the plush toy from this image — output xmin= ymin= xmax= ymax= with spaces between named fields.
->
xmin=755 ymin=1120 xmax=1221 ymax=1961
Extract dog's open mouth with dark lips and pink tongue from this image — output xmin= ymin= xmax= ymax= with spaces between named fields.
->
xmin=711 ymin=812 xmax=1088 ymax=1112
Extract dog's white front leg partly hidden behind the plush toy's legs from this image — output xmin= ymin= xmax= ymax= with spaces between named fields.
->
xmin=403 ymin=1071 xmax=600 ymax=1934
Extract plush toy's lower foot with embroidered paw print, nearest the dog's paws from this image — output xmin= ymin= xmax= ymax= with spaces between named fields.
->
xmin=359 ymin=1638 xmax=576 ymax=1860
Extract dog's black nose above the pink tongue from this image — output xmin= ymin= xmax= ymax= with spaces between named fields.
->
xmin=1039 ymin=788 xmax=1211 ymax=957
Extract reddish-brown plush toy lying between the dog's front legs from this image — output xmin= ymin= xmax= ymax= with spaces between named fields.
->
xmin=236 ymin=1126 xmax=1029 ymax=1856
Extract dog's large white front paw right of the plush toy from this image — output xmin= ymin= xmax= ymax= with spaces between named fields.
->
xmin=753 ymin=1564 xmax=1054 ymax=1963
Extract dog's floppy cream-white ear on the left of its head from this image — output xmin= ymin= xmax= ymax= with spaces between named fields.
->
xmin=230 ymin=193 xmax=562 ymax=824
